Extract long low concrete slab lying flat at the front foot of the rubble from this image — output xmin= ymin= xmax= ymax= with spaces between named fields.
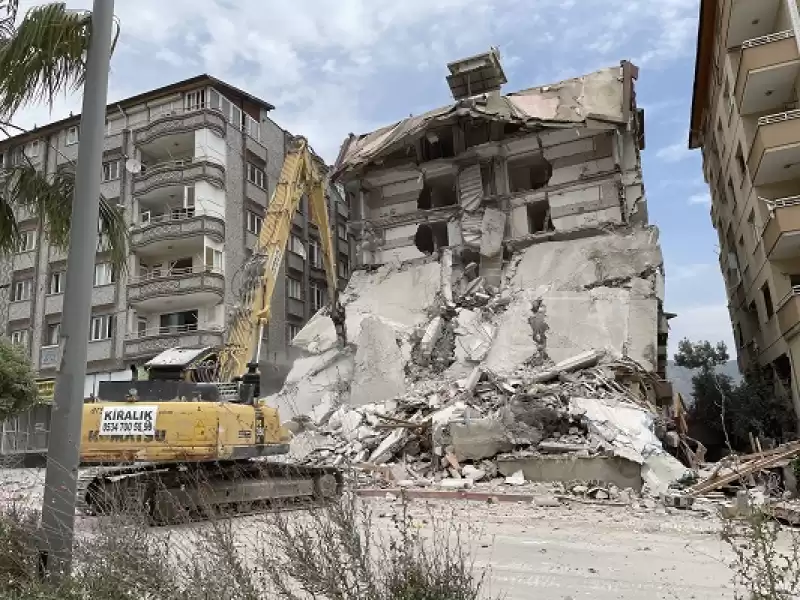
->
xmin=497 ymin=456 xmax=642 ymax=492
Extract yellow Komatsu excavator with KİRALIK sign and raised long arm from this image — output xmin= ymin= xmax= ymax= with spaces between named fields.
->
xmin=78 ymin=137 xmax=347 ymax=524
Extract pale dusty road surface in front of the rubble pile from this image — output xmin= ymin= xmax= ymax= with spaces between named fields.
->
xmin=372 ymin=502 xmax=733 ymax=600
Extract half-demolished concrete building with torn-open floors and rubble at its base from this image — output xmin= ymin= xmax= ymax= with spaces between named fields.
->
xmin=271 ymin=49 xmax=674 ymax=487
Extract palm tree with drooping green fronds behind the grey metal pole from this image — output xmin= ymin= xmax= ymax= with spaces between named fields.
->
xmin=0 ymin=0 xmax=128 ymax=269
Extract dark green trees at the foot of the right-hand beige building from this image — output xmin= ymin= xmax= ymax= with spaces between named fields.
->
xmin=675 ymin=339 xmax=795 ymax=451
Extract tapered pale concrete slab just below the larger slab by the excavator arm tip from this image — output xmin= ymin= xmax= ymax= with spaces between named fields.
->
xmin=350 ymin=317 xmax=406 ymax=406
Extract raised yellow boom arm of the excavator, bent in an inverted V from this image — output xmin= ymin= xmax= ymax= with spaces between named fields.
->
xmin=220 ymin=137 xmax=345 ymax=381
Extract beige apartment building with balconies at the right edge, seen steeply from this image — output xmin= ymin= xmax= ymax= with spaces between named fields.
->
xmin=689 ymin=0 xmax=800 ymax=415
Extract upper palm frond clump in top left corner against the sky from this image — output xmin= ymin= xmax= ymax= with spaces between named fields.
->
xmin=0 ymin=2 xmax=92 ymax=118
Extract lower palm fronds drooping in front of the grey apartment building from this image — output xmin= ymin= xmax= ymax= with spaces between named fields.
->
xmin=0 ymin=164 xmax=128 ymax=271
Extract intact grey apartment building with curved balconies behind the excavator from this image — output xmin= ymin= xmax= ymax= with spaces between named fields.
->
xmin=0 ymin=75 xmax=349 ymax=460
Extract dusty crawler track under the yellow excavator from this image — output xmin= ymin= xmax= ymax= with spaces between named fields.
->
xmin=78 ymin=460 xmax=343 ymax=526
